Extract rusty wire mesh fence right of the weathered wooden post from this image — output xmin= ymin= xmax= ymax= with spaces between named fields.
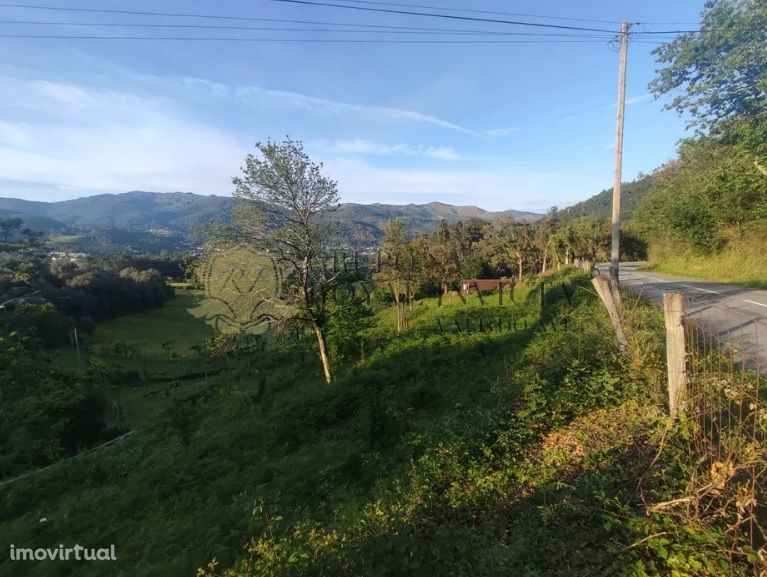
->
xmin=680 ymin=295 xmax=767 ymax=550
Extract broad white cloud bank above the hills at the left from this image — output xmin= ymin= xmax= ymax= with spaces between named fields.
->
xmin=0 ymin=77 xmax=245 ymax=193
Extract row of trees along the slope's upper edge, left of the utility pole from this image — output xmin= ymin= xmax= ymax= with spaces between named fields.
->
xmin=374 ymin=208 xmax=643 ymax=331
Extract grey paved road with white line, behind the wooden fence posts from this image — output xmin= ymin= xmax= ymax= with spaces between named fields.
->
xmin=599 ymin=263 xmax=767 ymax=370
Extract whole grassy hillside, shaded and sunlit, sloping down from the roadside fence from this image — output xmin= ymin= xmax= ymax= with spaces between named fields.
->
xmin=0 ymin=272 xmax=756 ymax=577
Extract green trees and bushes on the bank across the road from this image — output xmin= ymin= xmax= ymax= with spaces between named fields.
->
xmin=637 ymin=0 xmax=767 ymax=282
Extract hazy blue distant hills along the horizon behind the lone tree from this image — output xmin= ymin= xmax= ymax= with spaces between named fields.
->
xmin=0 ymin=191 xmax=542 ymax=251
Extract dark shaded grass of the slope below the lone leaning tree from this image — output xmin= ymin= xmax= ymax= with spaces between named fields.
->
xmin=0 ymin=278 xmax=534 ymax=575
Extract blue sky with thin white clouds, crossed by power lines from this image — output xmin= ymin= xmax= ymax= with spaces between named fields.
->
xmin=0 ymin=0 xmax=703 ymax=211
